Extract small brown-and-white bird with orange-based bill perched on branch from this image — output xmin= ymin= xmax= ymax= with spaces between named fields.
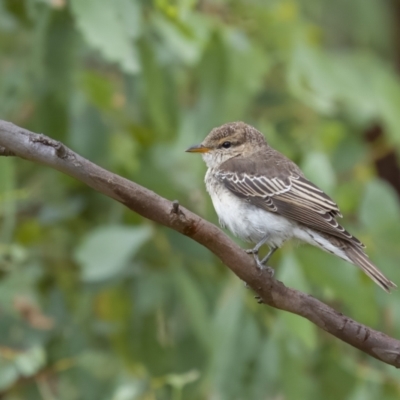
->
xmin=186 ymin=122 xmax=396 ymax=292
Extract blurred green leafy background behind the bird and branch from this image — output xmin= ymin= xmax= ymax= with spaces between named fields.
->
xmin=0 ymin=0 xmax=400 ymax=400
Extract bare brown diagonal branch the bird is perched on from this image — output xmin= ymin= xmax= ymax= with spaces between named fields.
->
xmin=0 ymin=120 xmax=400 ymax=368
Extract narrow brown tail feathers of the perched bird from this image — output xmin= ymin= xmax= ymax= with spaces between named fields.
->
xmin=343 ymin=245 xmax=397 ymax=293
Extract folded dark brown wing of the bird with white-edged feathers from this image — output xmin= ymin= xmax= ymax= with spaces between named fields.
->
xmin=217 ymin=164 xmax=364 ymax=247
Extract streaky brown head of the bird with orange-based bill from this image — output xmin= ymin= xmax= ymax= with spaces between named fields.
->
xmin=186 ymin=122 xmax=266 ymax=168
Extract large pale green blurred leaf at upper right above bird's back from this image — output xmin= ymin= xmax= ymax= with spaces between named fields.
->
xmin=288 ymin=41 xmax=381 ymax=123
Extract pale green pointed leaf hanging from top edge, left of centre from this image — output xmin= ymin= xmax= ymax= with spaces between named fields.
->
xmin=70 ymin=0 xmax=140 ymax=74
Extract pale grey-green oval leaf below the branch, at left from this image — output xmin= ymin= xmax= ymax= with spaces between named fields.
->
xmin=75 ymin=226 xmax=151 ymax=282
